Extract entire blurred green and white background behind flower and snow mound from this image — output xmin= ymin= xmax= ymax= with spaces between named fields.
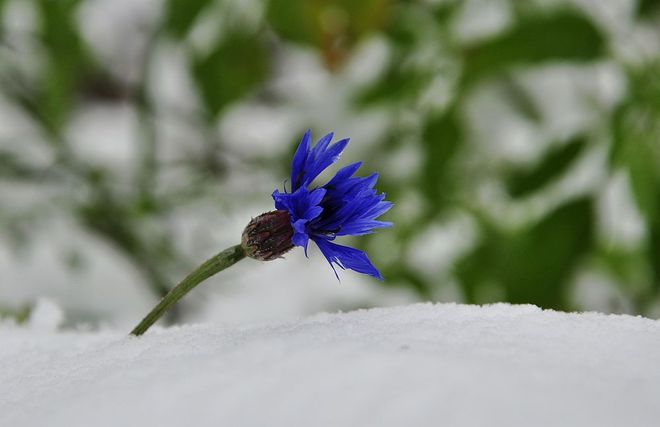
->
xmin=0 ymin=0 xmax=660 ymax=328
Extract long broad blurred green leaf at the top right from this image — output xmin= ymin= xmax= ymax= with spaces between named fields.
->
xmin=463 ymin=9 xmax=605 ymax=85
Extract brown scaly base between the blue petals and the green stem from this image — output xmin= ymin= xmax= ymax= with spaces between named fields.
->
xmin=241 ymin=210 xmax=293 ymax=261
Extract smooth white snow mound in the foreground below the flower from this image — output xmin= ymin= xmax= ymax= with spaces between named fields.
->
xmin=0 ymin=304 xmax=660 ymax=427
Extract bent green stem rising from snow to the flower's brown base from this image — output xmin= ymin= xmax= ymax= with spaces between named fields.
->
xmin=131 ymin=245 xmax=245 ymax=336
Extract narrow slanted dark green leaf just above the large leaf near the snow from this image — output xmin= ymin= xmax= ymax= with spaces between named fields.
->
xmin=505 ymin=136 xmax=586 ymax=197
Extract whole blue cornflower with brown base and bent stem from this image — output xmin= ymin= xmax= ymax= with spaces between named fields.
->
xmin=131 ymin=131 xmax=392 ymax=335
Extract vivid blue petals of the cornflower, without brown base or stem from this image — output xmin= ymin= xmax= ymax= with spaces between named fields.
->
xmin=273 ymin=130 xmax=392 ymax=280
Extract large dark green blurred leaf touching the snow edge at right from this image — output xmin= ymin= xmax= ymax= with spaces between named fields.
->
xmin=456 ymin=198 xmax=594 ymax=310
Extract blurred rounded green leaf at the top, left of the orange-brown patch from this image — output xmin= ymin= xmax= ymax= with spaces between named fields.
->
xmin=192 ymin=33 xmax=268 ymax=117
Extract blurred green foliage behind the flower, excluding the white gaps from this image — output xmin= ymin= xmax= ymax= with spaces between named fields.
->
xmin=0 ymin=0 xmax=660 ymax=320
